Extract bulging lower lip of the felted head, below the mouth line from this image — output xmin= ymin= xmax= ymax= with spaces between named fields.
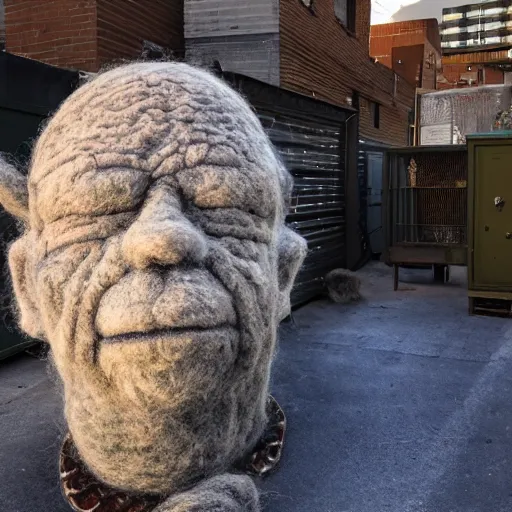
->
xmin=98 ymin=325 xmax=241 ymax=386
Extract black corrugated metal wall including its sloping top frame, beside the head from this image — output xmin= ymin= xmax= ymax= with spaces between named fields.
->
xmin=223 ymin=73 xmax=353 ymax=305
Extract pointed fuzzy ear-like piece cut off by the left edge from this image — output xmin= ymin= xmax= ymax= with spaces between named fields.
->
xmin=0 ymin=155 xmax=29 ymax=222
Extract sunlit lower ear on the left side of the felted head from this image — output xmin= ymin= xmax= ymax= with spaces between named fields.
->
xmin=9 ymin=234 xmax=45 ymax=340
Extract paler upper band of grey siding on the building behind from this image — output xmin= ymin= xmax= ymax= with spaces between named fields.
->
xmin=184 ymin=0 xmax=279 ymax=39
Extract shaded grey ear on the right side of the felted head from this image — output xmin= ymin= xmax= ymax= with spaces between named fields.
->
xmin=278 ymin=226 xmax=308 ymax=322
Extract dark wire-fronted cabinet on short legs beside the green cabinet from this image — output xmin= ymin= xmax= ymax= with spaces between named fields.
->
xmin=384 ymin=146 xmax=467 ymax=289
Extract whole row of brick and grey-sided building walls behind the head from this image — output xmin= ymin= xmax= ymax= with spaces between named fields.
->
xmin=4 ymin=0 xmax=414 ymax=145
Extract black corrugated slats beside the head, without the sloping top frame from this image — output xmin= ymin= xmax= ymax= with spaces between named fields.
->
xmin=260 ymin=115 xmax=346 ymax=304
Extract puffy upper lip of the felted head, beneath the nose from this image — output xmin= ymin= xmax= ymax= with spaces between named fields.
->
xmin=95 ymin=269 xmax=237 ymax=343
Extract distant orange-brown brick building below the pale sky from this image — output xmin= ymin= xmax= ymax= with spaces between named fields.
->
xmin=370 ymin=19 xmax=441 ymax=89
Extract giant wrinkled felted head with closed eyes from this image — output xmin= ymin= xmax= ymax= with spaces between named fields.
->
xmin=0 ymin=63 xmax=306 ymax=512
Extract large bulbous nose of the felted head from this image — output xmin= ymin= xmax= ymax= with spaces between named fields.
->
xmin=122 ymin=187 xmax=207 ymax=269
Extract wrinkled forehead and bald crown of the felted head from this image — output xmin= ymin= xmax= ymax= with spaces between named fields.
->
xmin=30 ymin=63 xmax=292 ymax=220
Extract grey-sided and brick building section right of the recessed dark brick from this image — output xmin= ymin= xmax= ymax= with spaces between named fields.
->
xmin=184 ymin=0 xmax=414 ymax=145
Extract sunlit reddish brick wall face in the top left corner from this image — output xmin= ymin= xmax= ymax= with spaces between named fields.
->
xmin=5 ymin=0 xmax=97 ymax=71
